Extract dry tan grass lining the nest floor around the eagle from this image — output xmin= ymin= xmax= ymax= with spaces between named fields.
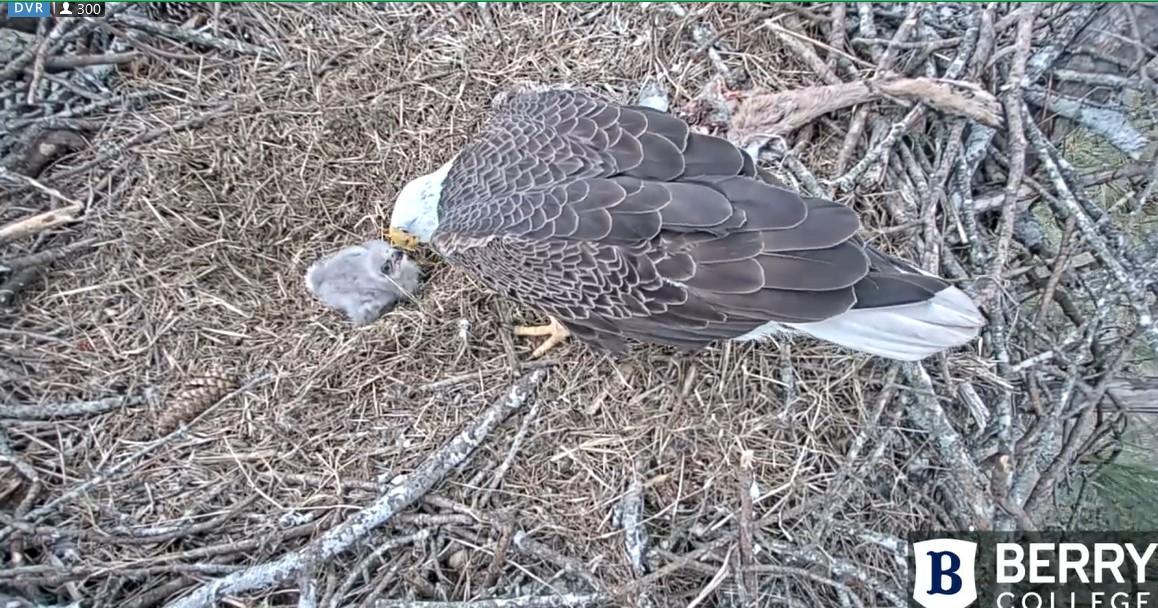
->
xmin=0 ymin=3 xmax=1144 ymax=607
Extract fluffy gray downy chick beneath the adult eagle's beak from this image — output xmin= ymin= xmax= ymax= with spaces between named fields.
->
xmin=306 ymin=240 xmax=420 ymax=325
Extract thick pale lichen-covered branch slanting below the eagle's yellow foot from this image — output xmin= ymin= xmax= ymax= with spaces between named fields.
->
xmin=174 ymin=369 xmax=545 ymax=608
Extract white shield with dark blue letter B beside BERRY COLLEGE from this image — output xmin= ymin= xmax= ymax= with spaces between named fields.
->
xmin=913 ymin=539 xmax=977 ymax=608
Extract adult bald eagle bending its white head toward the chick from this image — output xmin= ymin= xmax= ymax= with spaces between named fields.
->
xmin=390 ymin=89 xmax=984 ymax=360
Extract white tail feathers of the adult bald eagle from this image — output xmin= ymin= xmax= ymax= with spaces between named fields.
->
xmin=784 ymin=287 xmax=985 ymax=361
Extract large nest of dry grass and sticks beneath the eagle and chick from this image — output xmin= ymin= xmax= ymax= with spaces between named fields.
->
xmin=0 ymin=2 xmax=1158 ymax=608
